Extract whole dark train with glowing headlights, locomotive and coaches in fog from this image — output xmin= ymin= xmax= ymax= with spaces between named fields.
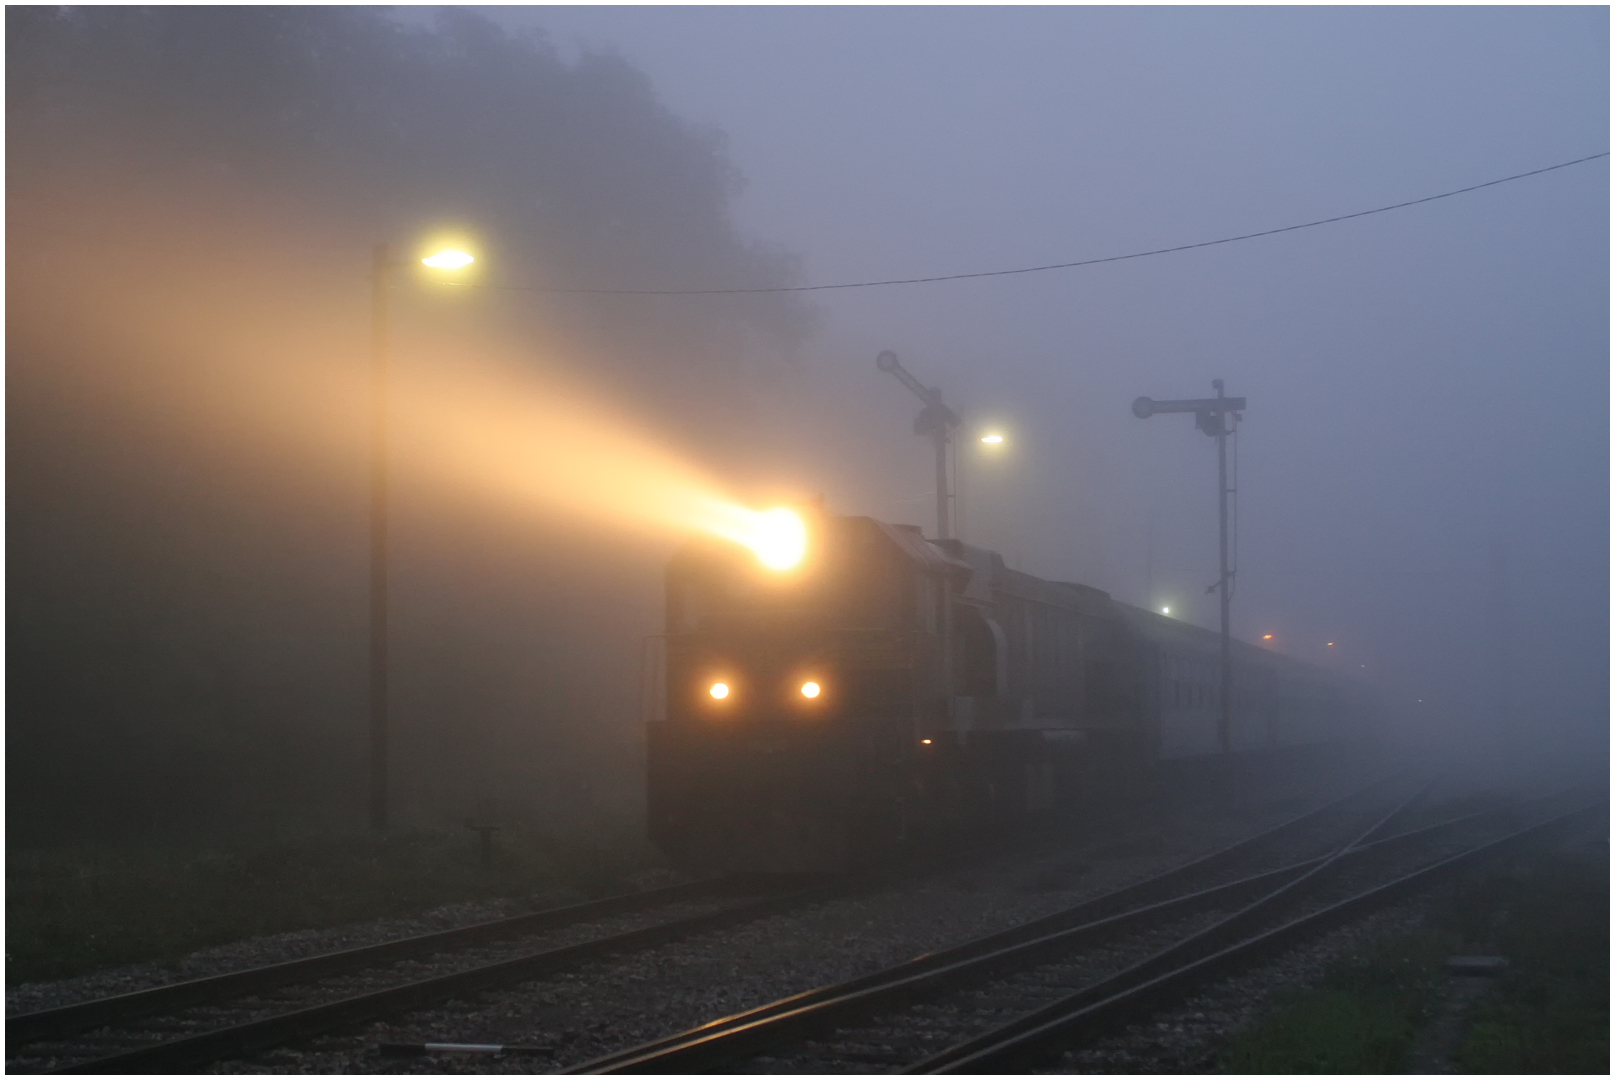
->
xmin=644 ymin=507 xmax=1373 ymax=872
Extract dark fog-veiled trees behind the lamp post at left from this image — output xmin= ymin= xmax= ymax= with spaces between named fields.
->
xmin=6 ymin=6 xmax=811 ymax=844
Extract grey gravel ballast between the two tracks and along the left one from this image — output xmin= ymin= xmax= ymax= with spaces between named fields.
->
xmin=8 ymin=761 xmax=1388 ymax=1072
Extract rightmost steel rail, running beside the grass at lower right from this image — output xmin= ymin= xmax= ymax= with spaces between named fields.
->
xmin=923 ymin=802 xmax=1605 ymax=1074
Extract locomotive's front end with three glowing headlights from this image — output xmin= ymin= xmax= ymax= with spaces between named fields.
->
xmin=646 ymin=512 xmax=945 ymax=872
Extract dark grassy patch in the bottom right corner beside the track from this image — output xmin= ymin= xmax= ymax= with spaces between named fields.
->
xmin=1223 ymin=854 xmax=1610 ymax=1075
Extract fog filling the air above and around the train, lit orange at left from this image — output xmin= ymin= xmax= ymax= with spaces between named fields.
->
xmin=6 ymin=8 xmax=1610 ymax=841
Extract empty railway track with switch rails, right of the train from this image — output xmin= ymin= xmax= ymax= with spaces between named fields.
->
xmin=568 ymin=784 xmax=1588 ymax=1074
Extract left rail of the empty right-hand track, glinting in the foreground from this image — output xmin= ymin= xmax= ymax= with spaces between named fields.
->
xmin=564 ymin=783 xmax=1440 ymax=1074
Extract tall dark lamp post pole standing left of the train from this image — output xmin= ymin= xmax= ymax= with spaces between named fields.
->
xmin=370 ymin=244 xmax=392 ymax=830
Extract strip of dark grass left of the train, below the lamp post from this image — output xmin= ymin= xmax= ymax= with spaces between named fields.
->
xmin=5 ymin=816 xmax=654 ymax=983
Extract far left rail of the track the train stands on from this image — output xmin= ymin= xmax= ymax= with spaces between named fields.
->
xmin=5 ymin=875 xmax=761 ymax=1046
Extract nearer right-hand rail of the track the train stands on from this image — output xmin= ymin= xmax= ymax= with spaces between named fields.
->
xmin=48 ymin=885 xmax=838 ymax=1074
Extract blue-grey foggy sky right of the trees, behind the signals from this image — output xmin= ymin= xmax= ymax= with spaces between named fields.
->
xmin=497 ymin=6 xmax=1609 ymax=755
